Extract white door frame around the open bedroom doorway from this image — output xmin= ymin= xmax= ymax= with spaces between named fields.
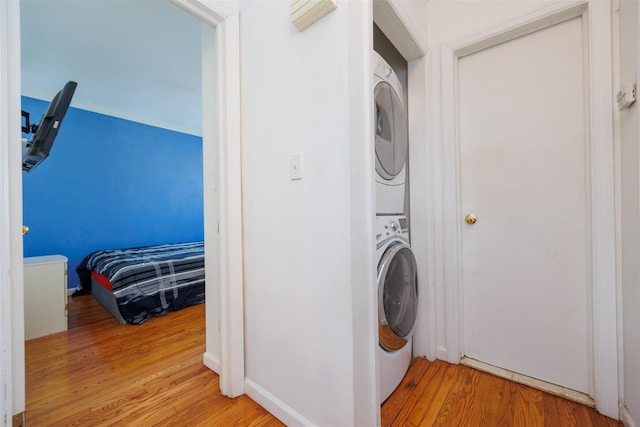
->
xmin=6 ymin=0 xmax=244 ymax=422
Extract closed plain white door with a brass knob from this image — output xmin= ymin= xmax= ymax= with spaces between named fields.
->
xmin=458 ymin=17 xmax=591 ymax=393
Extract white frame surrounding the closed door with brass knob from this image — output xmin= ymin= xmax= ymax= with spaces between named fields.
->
xmin=441 ymin=0 xmax=619 ymax=419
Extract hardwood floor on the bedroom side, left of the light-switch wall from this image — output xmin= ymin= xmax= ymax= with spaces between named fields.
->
xmin=25 ymin=295 xmax=283 ymax=427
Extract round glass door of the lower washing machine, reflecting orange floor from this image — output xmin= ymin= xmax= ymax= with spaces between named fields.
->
xmin=378 ymin=243 xmax=418 ymax=351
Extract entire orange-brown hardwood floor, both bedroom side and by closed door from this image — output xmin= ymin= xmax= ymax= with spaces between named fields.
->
xmin=26 ymin=296 xmax=621 ymax=427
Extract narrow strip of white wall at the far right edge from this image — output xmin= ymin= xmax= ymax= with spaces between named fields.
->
xmin=615 ymin=0 xmax=640 ymax=425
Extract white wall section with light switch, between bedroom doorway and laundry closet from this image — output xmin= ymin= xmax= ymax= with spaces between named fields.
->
xmin=238 ymin=1 xmax=376 ymax=426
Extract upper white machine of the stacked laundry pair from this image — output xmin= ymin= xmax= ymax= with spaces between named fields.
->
xmin=373 ymin=51 xmax=408 ymax=215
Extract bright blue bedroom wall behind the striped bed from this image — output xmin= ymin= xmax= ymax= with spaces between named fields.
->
xmin=22 ymin=97 xmax=204 ymax=288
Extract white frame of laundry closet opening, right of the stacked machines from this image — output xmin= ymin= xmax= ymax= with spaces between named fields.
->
xmin=371 ymin=0 xmax=438 ymax=360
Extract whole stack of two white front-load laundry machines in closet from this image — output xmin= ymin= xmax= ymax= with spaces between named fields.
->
xmin=373 ymin=51 xmax=418 ymax=403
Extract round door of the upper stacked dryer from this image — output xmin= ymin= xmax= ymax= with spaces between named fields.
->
xmin=374 ymin=82 xmax=407 ymax=180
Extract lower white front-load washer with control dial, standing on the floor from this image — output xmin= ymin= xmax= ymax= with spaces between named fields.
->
xmin=376 ymin=216 xmax=418 ymax=403
